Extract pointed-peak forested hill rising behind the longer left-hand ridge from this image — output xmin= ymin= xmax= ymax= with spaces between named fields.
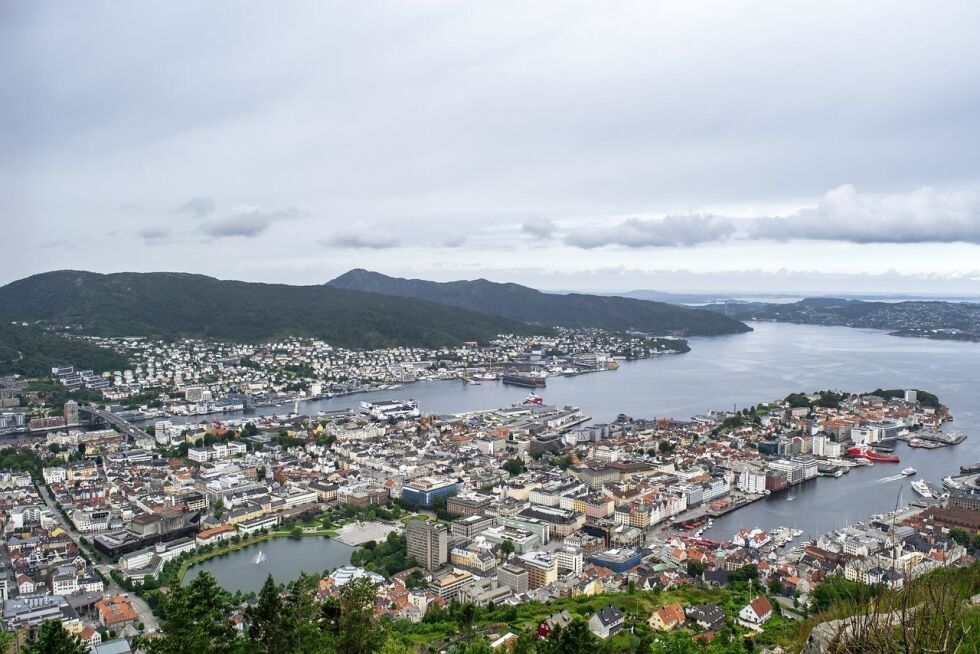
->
xmin=327 ymin=269 xmax=750 ymax=336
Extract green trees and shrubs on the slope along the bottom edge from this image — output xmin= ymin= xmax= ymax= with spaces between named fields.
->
xmin=23 ymin=563 xmax=980 ymax=654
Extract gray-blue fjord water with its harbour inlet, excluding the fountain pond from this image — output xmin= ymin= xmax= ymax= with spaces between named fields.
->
xmin=189 ymin=323 xmax=980 ymax=539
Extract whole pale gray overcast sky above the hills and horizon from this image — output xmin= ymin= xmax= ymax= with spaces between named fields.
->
xmin=0 ymin=0 xmax=980 ymax=293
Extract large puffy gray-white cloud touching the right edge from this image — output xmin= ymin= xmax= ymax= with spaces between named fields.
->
xmin=749 ymin=184 xmax=980 ymax=243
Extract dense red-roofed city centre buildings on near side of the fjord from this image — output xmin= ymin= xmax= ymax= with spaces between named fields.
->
xmin=4 ymin=382 xmax=980 ymax=638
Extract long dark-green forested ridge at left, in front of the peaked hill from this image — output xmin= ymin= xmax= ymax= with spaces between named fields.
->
xmin=0 ymin=271 xmax=546 ymax=348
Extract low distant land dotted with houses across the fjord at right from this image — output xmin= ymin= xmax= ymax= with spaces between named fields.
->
xmin=705 ymin=298 xmax=980 ymax=341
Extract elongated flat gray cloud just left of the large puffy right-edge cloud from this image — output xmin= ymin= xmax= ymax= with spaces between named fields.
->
xmin=565 ymin=214 xmax=735 ymax=248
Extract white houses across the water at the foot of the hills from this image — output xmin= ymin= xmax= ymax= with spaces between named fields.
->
xmin=0 ymin=329 xmax=686 ymax=433
